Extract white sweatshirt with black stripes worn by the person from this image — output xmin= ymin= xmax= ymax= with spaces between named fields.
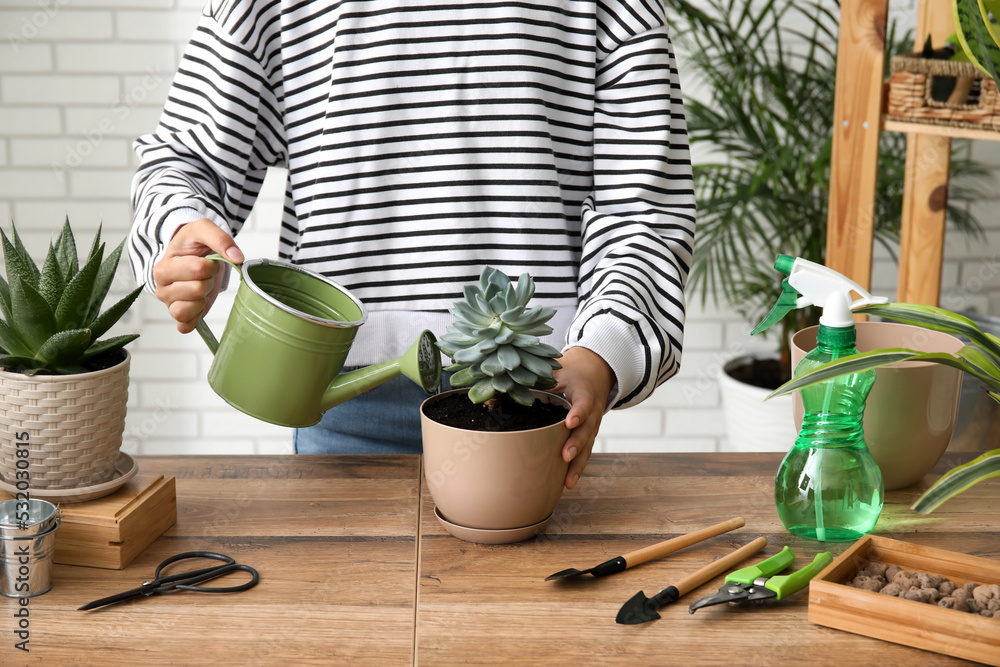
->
xmin=129 ymin=0 xmax=695 ymax=407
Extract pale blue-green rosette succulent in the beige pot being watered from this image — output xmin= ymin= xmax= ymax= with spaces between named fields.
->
xmin=438 ymin=266 xmax=562 ymax=408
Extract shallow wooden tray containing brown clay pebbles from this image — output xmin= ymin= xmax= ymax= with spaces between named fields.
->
xmin=809 ymin=535 xmax=1000 ymax=665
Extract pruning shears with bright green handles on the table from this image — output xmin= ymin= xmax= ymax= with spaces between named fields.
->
xmin=688 ymin=547 xmax=833 ymax=614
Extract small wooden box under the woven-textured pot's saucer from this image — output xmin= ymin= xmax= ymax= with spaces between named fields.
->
xmin=0 ymin=473 xmax=177 ymax=570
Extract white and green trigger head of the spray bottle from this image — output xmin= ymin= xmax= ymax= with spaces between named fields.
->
xmin=750 ymin=255 xmax=888 ymax=335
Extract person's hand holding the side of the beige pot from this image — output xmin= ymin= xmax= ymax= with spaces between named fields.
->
xmin=552 ymin=347 xmax=615 ymax=489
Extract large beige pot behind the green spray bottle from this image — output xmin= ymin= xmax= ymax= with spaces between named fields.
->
xmin=792 ymin=322 xmax=963 ymax=491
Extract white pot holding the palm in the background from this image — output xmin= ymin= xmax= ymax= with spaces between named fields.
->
xmin=719 ymin=353 xmax=798 ymax=452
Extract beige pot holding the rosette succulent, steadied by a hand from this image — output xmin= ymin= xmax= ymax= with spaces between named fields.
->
xmin=420 ymin=389 xmax=569 ymax=542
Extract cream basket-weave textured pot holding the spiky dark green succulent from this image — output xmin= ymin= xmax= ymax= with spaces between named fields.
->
xmin=0 ymin=351 xmax=131 ymax=490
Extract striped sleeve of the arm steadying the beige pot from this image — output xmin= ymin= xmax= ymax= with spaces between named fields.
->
xmin=568 ymin=17 xmax=695 ymax=408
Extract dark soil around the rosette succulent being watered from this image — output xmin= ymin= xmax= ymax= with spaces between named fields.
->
xmin=424 ymin=393 xmax=569 ymax=431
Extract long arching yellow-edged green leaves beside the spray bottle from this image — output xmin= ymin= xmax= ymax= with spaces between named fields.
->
xmin=768 ymin=303 xmax=1000 ymax=514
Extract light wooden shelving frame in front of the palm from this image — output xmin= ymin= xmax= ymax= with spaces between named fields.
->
xmin=826 ymin=0 xmax=972 ymax=305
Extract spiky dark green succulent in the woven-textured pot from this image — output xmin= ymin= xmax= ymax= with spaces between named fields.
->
xmin=0 ymin=218 xmax=142 ymax=375
